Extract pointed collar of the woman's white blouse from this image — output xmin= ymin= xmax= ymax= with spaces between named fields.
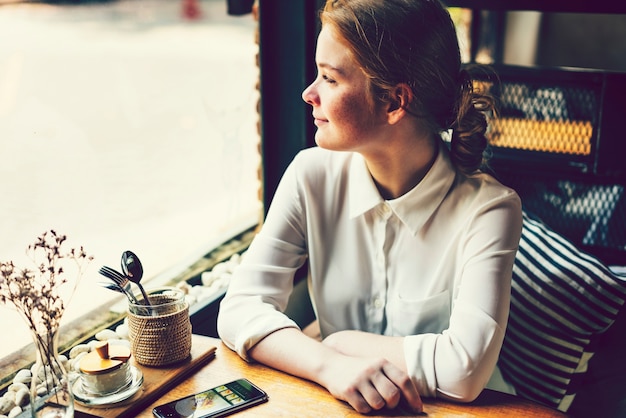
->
xmin=348 ymin=141 xmax=456 ymax=234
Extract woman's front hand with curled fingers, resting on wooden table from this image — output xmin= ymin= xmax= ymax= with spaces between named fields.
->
xmin=319 ymin=353 xmax=422 ymax=413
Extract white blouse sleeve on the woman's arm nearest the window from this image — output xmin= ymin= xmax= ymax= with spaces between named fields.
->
xmin=217 ymin=153 xmax=306 ymax=359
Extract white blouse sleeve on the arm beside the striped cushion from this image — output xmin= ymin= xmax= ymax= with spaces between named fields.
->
xmin=404 ymin=193 xmax=521 ymax=402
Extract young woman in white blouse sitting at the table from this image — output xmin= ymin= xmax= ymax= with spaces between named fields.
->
xmin=218 ymin=0 xmax=522 ymax=413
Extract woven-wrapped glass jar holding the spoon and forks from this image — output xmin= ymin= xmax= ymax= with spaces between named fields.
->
xmin=128 ymin=288 xmax=191 ymax=366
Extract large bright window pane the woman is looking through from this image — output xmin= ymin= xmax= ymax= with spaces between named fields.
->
xmin=0 ymin=0 xmax=261 ymax=358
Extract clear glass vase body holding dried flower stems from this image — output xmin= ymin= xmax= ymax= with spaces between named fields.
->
xmin=30 ymin=329 xmax=74 ymax=418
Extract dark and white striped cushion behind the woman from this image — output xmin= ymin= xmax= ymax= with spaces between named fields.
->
xmin=499 ymin=214 xmax=626 ymax=411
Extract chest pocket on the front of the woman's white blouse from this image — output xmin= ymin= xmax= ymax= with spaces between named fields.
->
xmin=388 ymin=290 xmax=450 ymax=336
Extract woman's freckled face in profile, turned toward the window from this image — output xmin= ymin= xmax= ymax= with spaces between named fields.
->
xmin=302 ymin=26 xmax=386 ymax=151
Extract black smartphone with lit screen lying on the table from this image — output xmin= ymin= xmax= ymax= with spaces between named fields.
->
xmin=152 ymin=379 xmax=268 ymax=418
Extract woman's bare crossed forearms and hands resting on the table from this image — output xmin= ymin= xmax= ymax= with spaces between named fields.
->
xmin=248 ymin=328 xmax=422 ymax=413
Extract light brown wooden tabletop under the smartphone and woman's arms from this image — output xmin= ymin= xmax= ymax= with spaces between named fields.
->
xmin=76 ymin=335 xmax=566 ymax=418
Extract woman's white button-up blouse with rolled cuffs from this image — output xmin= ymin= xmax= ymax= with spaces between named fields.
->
xmin=218 ymin=143 xmax=522 ymax=399
